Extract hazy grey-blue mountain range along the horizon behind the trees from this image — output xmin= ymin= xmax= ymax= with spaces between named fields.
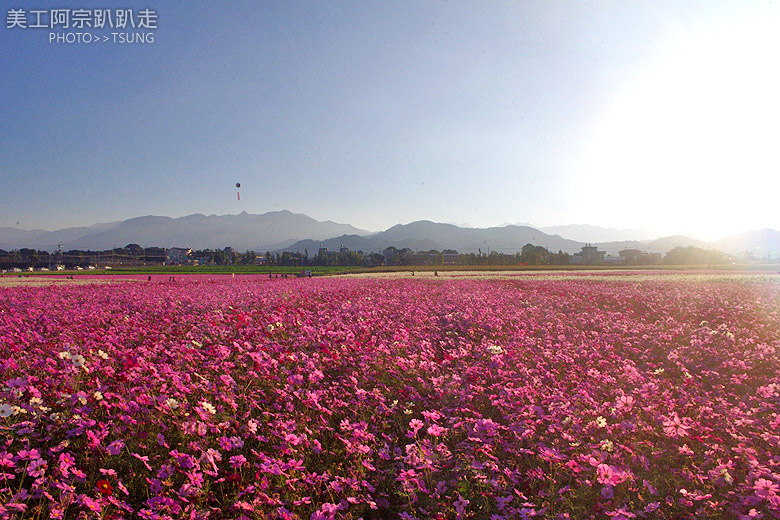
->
xmin=0 ymin=211 xmax=780 ymax=258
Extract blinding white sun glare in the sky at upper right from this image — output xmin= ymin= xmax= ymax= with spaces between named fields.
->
xmin=579 ymin=8 xmax=780 ymax=239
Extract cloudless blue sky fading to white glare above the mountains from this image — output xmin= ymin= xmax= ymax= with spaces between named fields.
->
xmin=0 ymin=0 xmax=780 ymax=238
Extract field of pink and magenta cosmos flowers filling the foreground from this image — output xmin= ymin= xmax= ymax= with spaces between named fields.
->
xmin=0 ymin=275 xmax=780 ymax=520
